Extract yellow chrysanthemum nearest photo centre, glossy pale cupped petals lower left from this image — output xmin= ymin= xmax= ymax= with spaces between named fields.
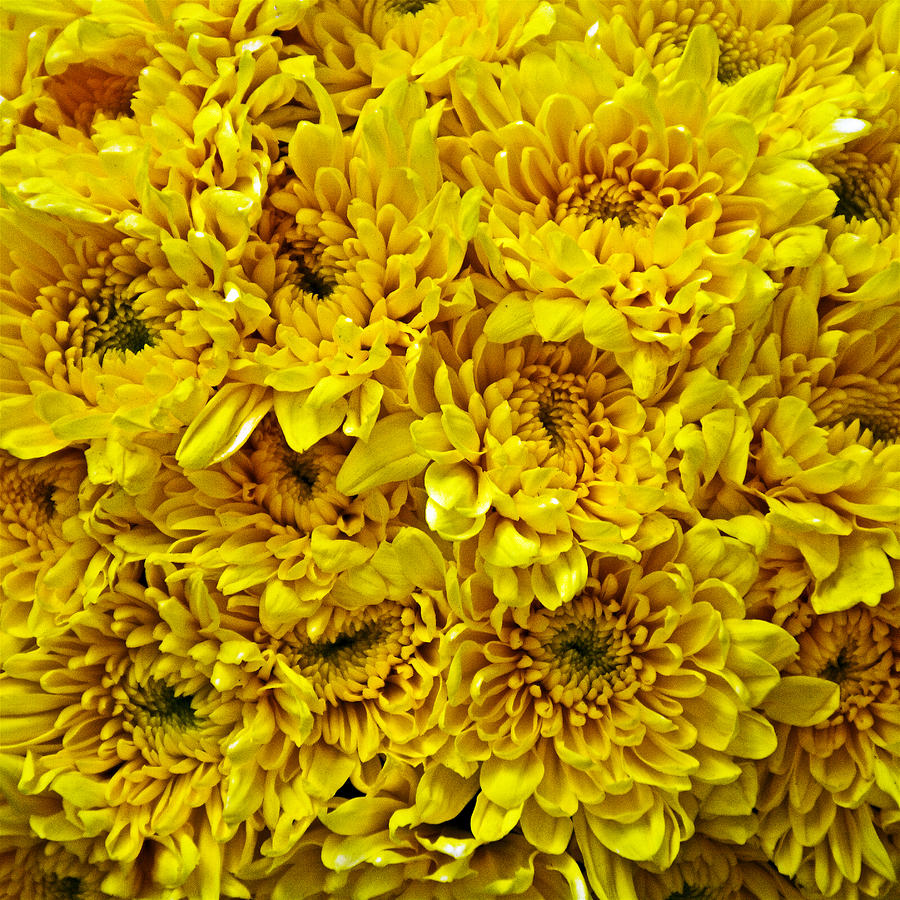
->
xmin=396 ymin=315 xmax=671 ymax=608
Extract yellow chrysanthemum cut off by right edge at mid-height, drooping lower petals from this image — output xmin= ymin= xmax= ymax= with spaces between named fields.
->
xmin=712 ymin=258 xmax=900 ymax=612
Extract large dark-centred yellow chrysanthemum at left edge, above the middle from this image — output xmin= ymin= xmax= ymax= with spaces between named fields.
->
xmin=0 ymin=204 xmax=248 ymax=491
